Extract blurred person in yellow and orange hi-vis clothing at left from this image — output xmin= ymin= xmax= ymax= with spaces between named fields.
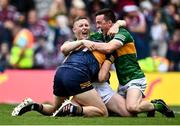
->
xmin=9 ymin=23 xmax=34 ymax=69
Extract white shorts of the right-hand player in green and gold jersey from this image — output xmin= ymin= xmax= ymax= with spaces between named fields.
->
xmin=118 ymin=77 xmax=147 ymax=97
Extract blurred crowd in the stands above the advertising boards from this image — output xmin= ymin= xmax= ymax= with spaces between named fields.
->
xmin=0 ymin=0 xmax=180 ymax=72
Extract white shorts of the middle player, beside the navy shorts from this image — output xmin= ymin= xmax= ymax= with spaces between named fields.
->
xmin=92 ymin=82 xmax=115 ymax=104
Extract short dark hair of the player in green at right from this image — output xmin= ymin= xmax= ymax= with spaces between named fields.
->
xmin=95 ymin=8 xmax=116 ymax=23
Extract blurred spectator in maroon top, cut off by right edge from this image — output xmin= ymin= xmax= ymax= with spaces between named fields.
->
xmin=167 ymin=29 xmax=180 ymax=71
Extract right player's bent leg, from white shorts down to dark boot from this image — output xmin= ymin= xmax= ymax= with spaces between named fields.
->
xmin=126 ymin=78 xmax=174 ymax=117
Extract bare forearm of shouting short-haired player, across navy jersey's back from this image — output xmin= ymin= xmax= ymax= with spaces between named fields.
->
xmin=60 ymin=41 xmax=83 ymax=56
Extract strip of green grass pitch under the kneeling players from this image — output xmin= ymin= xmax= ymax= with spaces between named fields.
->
xmin=0 ymin=104 xmax=180 ymax=125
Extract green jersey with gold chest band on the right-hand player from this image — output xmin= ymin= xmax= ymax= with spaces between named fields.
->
xmin=91 ymin=28 xmax=145 ymax=85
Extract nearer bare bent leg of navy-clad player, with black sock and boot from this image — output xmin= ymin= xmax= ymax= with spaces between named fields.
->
xmin=53 ymin=89 xmax=108 ymax=117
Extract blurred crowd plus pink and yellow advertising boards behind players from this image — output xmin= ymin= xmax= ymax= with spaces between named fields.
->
xmin=0 ymin=0 xmax=180 ymax=105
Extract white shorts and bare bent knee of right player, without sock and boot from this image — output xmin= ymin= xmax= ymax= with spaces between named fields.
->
xmin=118 ymin=78 xmax=154 ymax=113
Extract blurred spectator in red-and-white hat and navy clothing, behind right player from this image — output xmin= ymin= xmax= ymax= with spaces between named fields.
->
xmin=123 ymin=5 xmax=150 ymax=59
